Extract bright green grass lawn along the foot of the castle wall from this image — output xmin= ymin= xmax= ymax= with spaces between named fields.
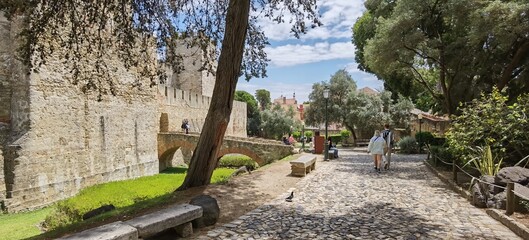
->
xmin=0 ymin=168 xmax=234 ymax=240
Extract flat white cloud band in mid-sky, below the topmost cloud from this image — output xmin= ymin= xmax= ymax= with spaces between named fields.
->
xmin=266 ymin=42 xmax=355 ymax=67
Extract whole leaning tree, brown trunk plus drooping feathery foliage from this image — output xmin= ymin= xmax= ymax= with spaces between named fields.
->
xmin=0 ymin=0 xmax=321 ymax=190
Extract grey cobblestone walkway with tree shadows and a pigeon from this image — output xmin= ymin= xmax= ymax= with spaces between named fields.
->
xmin=195 ymin=150 xmax=520 ymax=239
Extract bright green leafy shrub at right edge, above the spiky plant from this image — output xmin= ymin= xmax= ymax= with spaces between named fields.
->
xmin=446 ymin=89 xmax=529 ymax=164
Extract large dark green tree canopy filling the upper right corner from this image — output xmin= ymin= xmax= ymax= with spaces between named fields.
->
xmin=353 ymin=0 xmax=529 ymax=114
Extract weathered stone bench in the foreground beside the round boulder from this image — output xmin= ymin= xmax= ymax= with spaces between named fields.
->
xmin=60 ymin=204 xmax=202 ymax=240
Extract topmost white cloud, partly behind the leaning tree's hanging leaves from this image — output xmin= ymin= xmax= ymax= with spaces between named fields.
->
xmin=260 ymin=0 xmax=365 ymax=41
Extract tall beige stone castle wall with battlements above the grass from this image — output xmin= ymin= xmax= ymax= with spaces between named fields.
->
xmin=0 ymin=14 xmax=246 ymax=212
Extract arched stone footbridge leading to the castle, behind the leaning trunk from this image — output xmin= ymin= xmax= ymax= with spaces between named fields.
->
xmin=158 ymin=132 xmax=294 ymax=168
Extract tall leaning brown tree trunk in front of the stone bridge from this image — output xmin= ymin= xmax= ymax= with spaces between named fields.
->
xmin=178 ymin=0 xmax=250 ymax=190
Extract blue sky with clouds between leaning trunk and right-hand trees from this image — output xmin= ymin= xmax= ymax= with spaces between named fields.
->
xmin=237 ymin=0 xmax=383 ymax=103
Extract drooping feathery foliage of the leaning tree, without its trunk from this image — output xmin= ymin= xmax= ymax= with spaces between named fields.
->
xmin=0 ymin=0 xmax=321 ymax=94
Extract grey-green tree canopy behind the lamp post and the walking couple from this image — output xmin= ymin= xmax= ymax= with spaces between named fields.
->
xmin=305 ymin=70 xmax=415 ymax=140
